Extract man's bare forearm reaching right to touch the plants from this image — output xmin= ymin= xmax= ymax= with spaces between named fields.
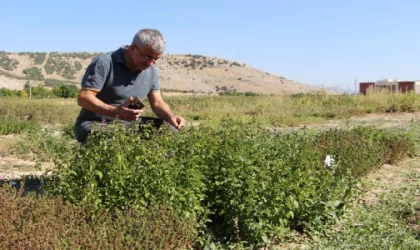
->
xmin=147 ymin=90 xmax=185 ymax=129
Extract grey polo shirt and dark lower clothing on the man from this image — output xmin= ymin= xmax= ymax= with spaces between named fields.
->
xmin=75 ymin=47 xmax=160 ymax=141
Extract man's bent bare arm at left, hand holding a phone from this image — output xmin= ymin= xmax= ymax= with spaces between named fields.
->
xmin=77 ymin=88 xmax=143 ymax=121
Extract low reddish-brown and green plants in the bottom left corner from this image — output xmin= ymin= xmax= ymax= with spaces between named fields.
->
xmin=0 ymin=185 xmax=197 ymax=250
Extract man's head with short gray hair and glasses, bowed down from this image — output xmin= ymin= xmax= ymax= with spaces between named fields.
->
xmin=129 ymin=29 xmax=166 ymax=70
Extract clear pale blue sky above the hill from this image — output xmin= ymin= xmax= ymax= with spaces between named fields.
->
xmin=0 ymin=0 xmax=420 ymax=89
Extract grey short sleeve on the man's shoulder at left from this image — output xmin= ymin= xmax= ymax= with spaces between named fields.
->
xmin=81 ymin=58 xmax=110 ymax=91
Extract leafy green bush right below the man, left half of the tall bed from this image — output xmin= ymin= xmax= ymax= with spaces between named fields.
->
xmin=44 ymin=124 xmax=210 ymax=229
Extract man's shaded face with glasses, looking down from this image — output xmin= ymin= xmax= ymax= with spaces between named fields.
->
xmin=130 ymin=45 xmax=162 ymax=70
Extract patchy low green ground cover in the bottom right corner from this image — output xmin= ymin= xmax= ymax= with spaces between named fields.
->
xmin=314 ymin=162 xmax=420 ymax=250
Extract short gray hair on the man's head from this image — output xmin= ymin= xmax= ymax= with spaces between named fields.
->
xmin=132 ymin=29 xmax=166 ymax=54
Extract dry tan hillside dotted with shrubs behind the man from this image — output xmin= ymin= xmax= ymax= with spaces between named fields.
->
xmin=0 ymin=52 xmax=320 ymax=94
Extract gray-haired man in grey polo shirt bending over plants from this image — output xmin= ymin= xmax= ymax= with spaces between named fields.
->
xmin=75 ymin=29 xmax=185 ymax=142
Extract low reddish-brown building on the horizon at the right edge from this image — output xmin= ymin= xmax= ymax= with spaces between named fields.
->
xmin=359 ymin=79 xmax=420 ymax=95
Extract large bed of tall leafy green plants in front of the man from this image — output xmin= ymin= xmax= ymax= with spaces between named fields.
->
xmin=41 ymin=121 xmax=412 ymax=247
